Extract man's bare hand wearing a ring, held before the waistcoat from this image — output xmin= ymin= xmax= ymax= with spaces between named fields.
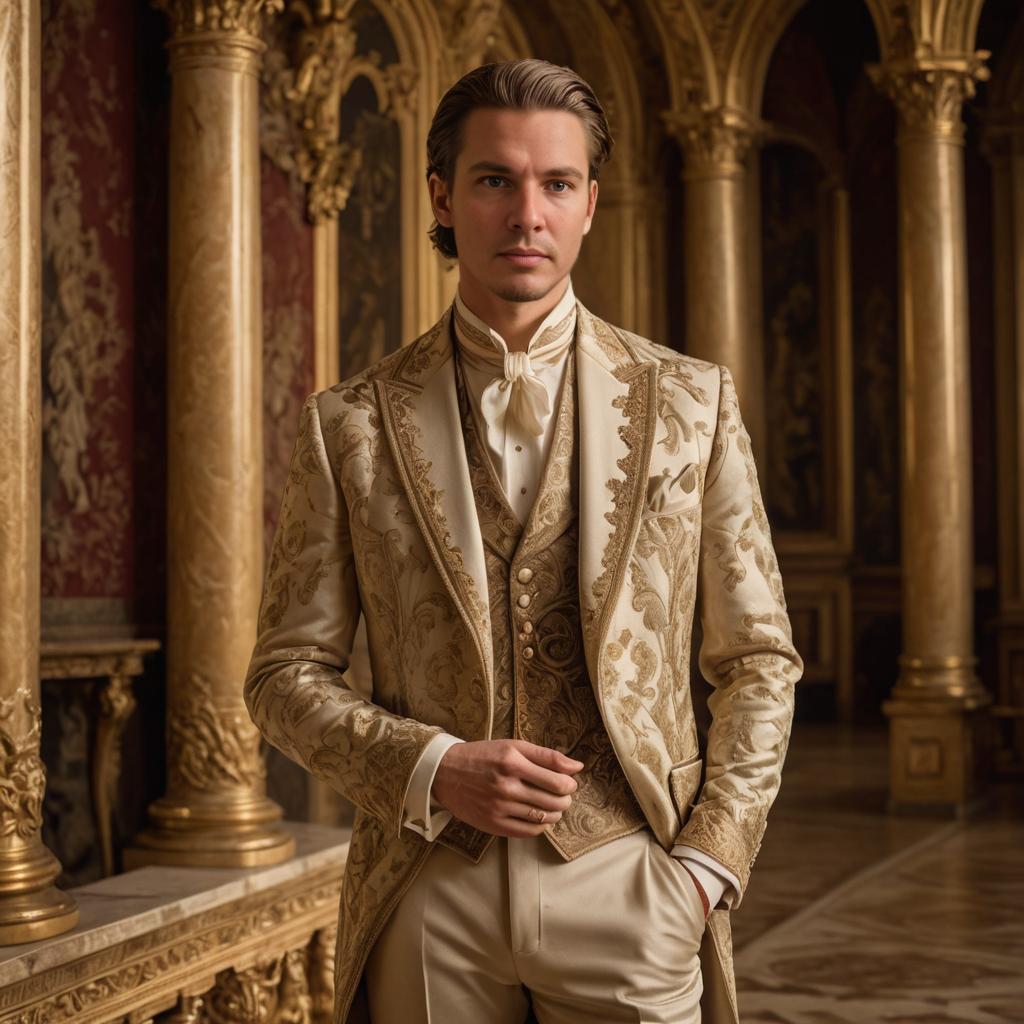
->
xmin=431 ymin=739 xmax=583 ymax=839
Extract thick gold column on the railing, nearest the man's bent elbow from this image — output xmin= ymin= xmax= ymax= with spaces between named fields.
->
xmin=126 ymin=0 xmax=294 ymax=866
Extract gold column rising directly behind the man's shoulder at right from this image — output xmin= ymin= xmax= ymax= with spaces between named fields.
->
xmin=666 ymin=108 xmax=765 ymax=465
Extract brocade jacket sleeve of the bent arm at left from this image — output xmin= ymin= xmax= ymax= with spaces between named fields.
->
xmin=245 ymin=395 xmax=443 ymax=836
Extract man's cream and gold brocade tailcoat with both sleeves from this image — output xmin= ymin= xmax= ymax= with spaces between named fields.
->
xmin=245 ymin=303 xmax=803 ymax=1024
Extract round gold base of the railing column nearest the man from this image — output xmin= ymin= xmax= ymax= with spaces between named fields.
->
xmin=124 ymin=797 xmax=295 ymax=870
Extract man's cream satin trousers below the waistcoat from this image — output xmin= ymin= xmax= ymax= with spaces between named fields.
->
xmin=366 ymin=828 xmax=705 ymax=1024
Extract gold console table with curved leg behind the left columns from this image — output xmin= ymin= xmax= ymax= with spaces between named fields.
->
xmin=39 ymin=637 xmax=160 ymax=877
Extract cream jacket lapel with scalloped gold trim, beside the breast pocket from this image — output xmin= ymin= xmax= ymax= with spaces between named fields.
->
xmin=577 ymin=304 xmax=657 ymax=701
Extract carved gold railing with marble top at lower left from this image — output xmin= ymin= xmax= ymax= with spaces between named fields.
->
xmin=0 ymin=823 xmax=349 ymax=1024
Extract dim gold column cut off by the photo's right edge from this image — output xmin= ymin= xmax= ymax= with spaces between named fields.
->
xmin=985 ymin=110 xmax=1024 ymax=765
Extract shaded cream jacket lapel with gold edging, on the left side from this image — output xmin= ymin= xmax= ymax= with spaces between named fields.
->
xmin=376 ymin=309 xmax=494 ymax=696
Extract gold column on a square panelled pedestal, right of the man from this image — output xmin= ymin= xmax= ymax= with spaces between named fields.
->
xmin=871 ymin=56 xmax=988 ymax=808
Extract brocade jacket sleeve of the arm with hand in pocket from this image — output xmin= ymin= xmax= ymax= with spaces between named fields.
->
xmin=677 ymin=367 xmax=804 ymax=906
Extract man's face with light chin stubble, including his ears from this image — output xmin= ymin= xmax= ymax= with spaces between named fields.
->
xmin=429 ymin=109 xmax=597 ymax=302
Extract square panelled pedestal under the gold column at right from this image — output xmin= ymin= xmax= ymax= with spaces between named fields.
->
xmin=883 ymin=686 xmax=991 ymax=814
